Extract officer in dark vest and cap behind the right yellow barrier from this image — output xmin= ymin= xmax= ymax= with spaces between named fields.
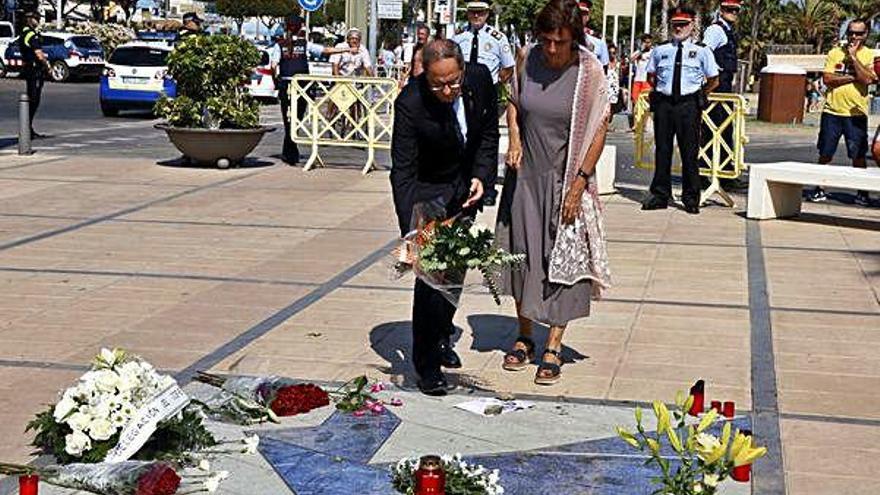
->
xmin=703 ymin=0 xmax=747 ymax=189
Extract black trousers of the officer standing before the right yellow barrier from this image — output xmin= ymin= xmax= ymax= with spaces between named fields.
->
xmin=651 ymin=94 xmax=702 ymax=205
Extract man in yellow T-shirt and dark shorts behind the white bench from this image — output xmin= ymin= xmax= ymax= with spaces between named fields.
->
xmin=809 ymin=19 xmax=877 ymax=206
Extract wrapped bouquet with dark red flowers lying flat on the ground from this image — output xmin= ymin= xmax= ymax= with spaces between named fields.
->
xmin=196 ymin=372 xmax=330 ymax=424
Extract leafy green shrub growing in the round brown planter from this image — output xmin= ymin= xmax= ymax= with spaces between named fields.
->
xmin=155 ymin=35 xmax=260 ymax=129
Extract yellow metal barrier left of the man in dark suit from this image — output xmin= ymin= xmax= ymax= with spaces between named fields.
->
xmin=290 ymin=75 xmax=398 ymax=174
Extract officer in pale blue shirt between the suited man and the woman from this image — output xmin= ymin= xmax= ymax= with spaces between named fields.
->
xmin=453 ymin=1 xmax=516 ymax=206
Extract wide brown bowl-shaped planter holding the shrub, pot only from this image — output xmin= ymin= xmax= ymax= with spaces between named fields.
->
xmin=156 ymin=124 xmax=275 ymax=168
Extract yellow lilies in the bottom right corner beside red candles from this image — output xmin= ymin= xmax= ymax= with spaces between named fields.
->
xmin=617 ymin=392 xmax=767 ymax=495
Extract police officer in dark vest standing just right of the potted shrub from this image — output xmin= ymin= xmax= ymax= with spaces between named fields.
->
xmin=275 ymin=15 xmax=349 ymax=165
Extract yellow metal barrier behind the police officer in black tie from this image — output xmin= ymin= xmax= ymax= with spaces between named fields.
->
xmin=634 ymin=92 xmax=748 ymax=207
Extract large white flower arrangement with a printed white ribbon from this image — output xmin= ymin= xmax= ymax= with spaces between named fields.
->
xmin=27 ymin=349 xmax=216 ymax=464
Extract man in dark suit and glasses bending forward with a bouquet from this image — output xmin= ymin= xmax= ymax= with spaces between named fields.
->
xmin=391 ymin=40 xmax=498 ymax=395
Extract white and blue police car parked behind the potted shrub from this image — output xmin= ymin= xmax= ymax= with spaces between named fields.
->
xmin=100 ymin=42 xmax=177 ymax=117
